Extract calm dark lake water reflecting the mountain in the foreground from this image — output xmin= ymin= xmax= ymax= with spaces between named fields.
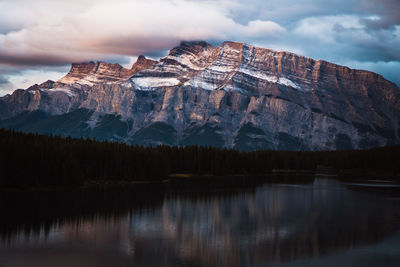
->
xmin=0 ymin=178 xmax=400 ymax=267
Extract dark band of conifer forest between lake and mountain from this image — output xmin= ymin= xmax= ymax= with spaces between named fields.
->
xmin=0 ymin=129 xmax=400 ymax=188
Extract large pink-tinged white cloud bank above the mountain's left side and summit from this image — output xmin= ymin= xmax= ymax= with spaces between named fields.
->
xmin=0 ymin=0 xmax=285 ymax=65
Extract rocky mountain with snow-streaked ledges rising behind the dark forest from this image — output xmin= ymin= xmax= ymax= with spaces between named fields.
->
xmin=0 ymin=41 xmax=400 ymax=151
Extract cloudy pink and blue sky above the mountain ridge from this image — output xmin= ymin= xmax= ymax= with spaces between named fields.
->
xmin=0 ymin=0 xmax=400 ymax=95
